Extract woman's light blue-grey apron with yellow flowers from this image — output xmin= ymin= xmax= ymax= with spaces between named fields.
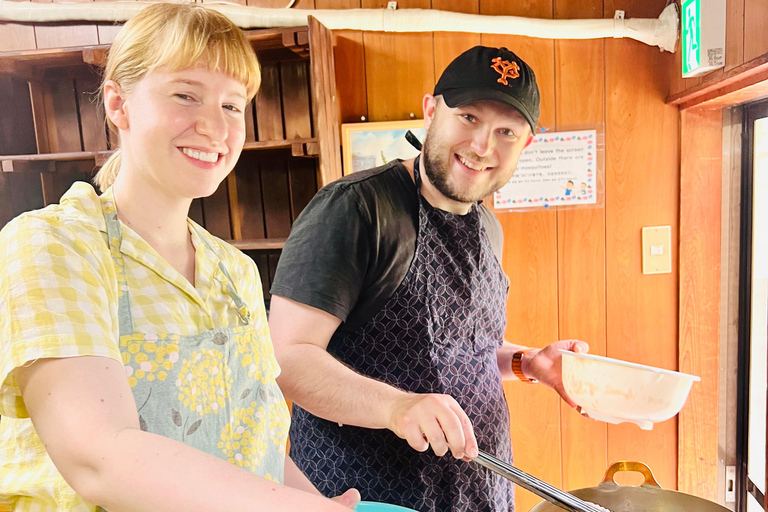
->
xmin=101 ymin=192 xmax=290 ymax=492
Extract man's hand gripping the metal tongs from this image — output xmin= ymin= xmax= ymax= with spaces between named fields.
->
xmin=390 ymin=394 xmax=477 ymax=459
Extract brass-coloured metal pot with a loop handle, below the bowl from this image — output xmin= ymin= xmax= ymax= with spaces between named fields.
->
xmin=530 ymin=462 xmax=730 ymax=512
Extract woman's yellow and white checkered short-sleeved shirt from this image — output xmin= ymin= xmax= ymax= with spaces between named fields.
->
xmin=0 ymin=182 xmax=269 ymax=512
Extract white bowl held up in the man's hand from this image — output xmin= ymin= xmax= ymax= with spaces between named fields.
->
xmin=560 ymin=350 xmax=701 ymax=430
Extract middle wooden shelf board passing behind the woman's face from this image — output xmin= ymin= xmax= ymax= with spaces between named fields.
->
xmin=0 ymin=138 xmax=320 ymax=172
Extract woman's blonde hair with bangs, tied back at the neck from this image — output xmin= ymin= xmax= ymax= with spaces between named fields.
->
xmin=93 ymin=3 xmax=261 ymax=191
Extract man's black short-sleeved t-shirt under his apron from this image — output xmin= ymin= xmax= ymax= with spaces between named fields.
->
xmin=271 ymin=160 xmax=503 ymax=336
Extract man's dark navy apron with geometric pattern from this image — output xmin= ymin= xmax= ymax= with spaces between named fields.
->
xmin=291 ymin=157 xmax=514 ymax=512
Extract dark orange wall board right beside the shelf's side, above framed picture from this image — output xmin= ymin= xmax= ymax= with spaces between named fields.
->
xmin=333 ymin=30 xmax=368 ymax=123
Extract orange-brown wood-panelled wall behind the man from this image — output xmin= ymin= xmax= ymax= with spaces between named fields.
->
xmin=0 ymin=0 xmax=680 ymax=511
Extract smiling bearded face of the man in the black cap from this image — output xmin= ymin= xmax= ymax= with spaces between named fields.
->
xmin=424 ymin=96 xmax=531 ymax=203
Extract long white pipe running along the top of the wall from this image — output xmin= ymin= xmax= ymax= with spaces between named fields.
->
xmin=0 ymin=0 xmax=678 ymax=52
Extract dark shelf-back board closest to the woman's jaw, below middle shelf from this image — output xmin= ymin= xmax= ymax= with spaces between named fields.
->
xmin=232 ymin=152 xmax=265 ymax=240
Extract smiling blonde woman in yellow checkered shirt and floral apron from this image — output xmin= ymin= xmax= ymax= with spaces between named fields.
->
xmin=0 ymin=4 xmax=359 ymax=512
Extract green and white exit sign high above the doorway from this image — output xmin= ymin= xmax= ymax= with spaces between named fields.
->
xmin=680 ymin=0 xmax=726 ymax=78
